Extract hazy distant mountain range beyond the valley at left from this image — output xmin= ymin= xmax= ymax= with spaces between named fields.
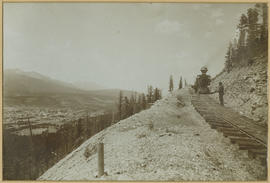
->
xmin=3 ymin=69 xmax=133 ymax=110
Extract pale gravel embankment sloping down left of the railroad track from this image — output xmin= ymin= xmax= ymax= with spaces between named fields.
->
xmin=39 ymin=88 xmax=266 ymax=181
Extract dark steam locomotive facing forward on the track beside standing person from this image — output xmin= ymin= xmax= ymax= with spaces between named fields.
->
xmin=193 ymin=67 xmax=211 ymax=94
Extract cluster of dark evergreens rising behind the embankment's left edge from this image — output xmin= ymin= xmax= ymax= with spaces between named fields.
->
xmin=117 ymin=85 xmax=162 ymax=120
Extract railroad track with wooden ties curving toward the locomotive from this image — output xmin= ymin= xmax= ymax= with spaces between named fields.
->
xmin=191 ymin=94 xmax=267 ymax=165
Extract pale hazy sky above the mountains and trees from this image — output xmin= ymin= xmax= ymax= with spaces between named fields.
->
xmin=3 ymin=3 xmax=254 ymax=92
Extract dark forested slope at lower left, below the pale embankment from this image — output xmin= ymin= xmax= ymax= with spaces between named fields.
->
xmin=3 ymin=113 xmax=114 ymax=180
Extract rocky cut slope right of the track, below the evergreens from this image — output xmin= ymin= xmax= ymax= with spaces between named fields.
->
xmin=210 ymin=56 xmax=268 ymax=125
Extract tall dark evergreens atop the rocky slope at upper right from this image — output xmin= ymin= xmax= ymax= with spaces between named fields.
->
xmin=225 ymin=3 xmax=268 ymax=72
